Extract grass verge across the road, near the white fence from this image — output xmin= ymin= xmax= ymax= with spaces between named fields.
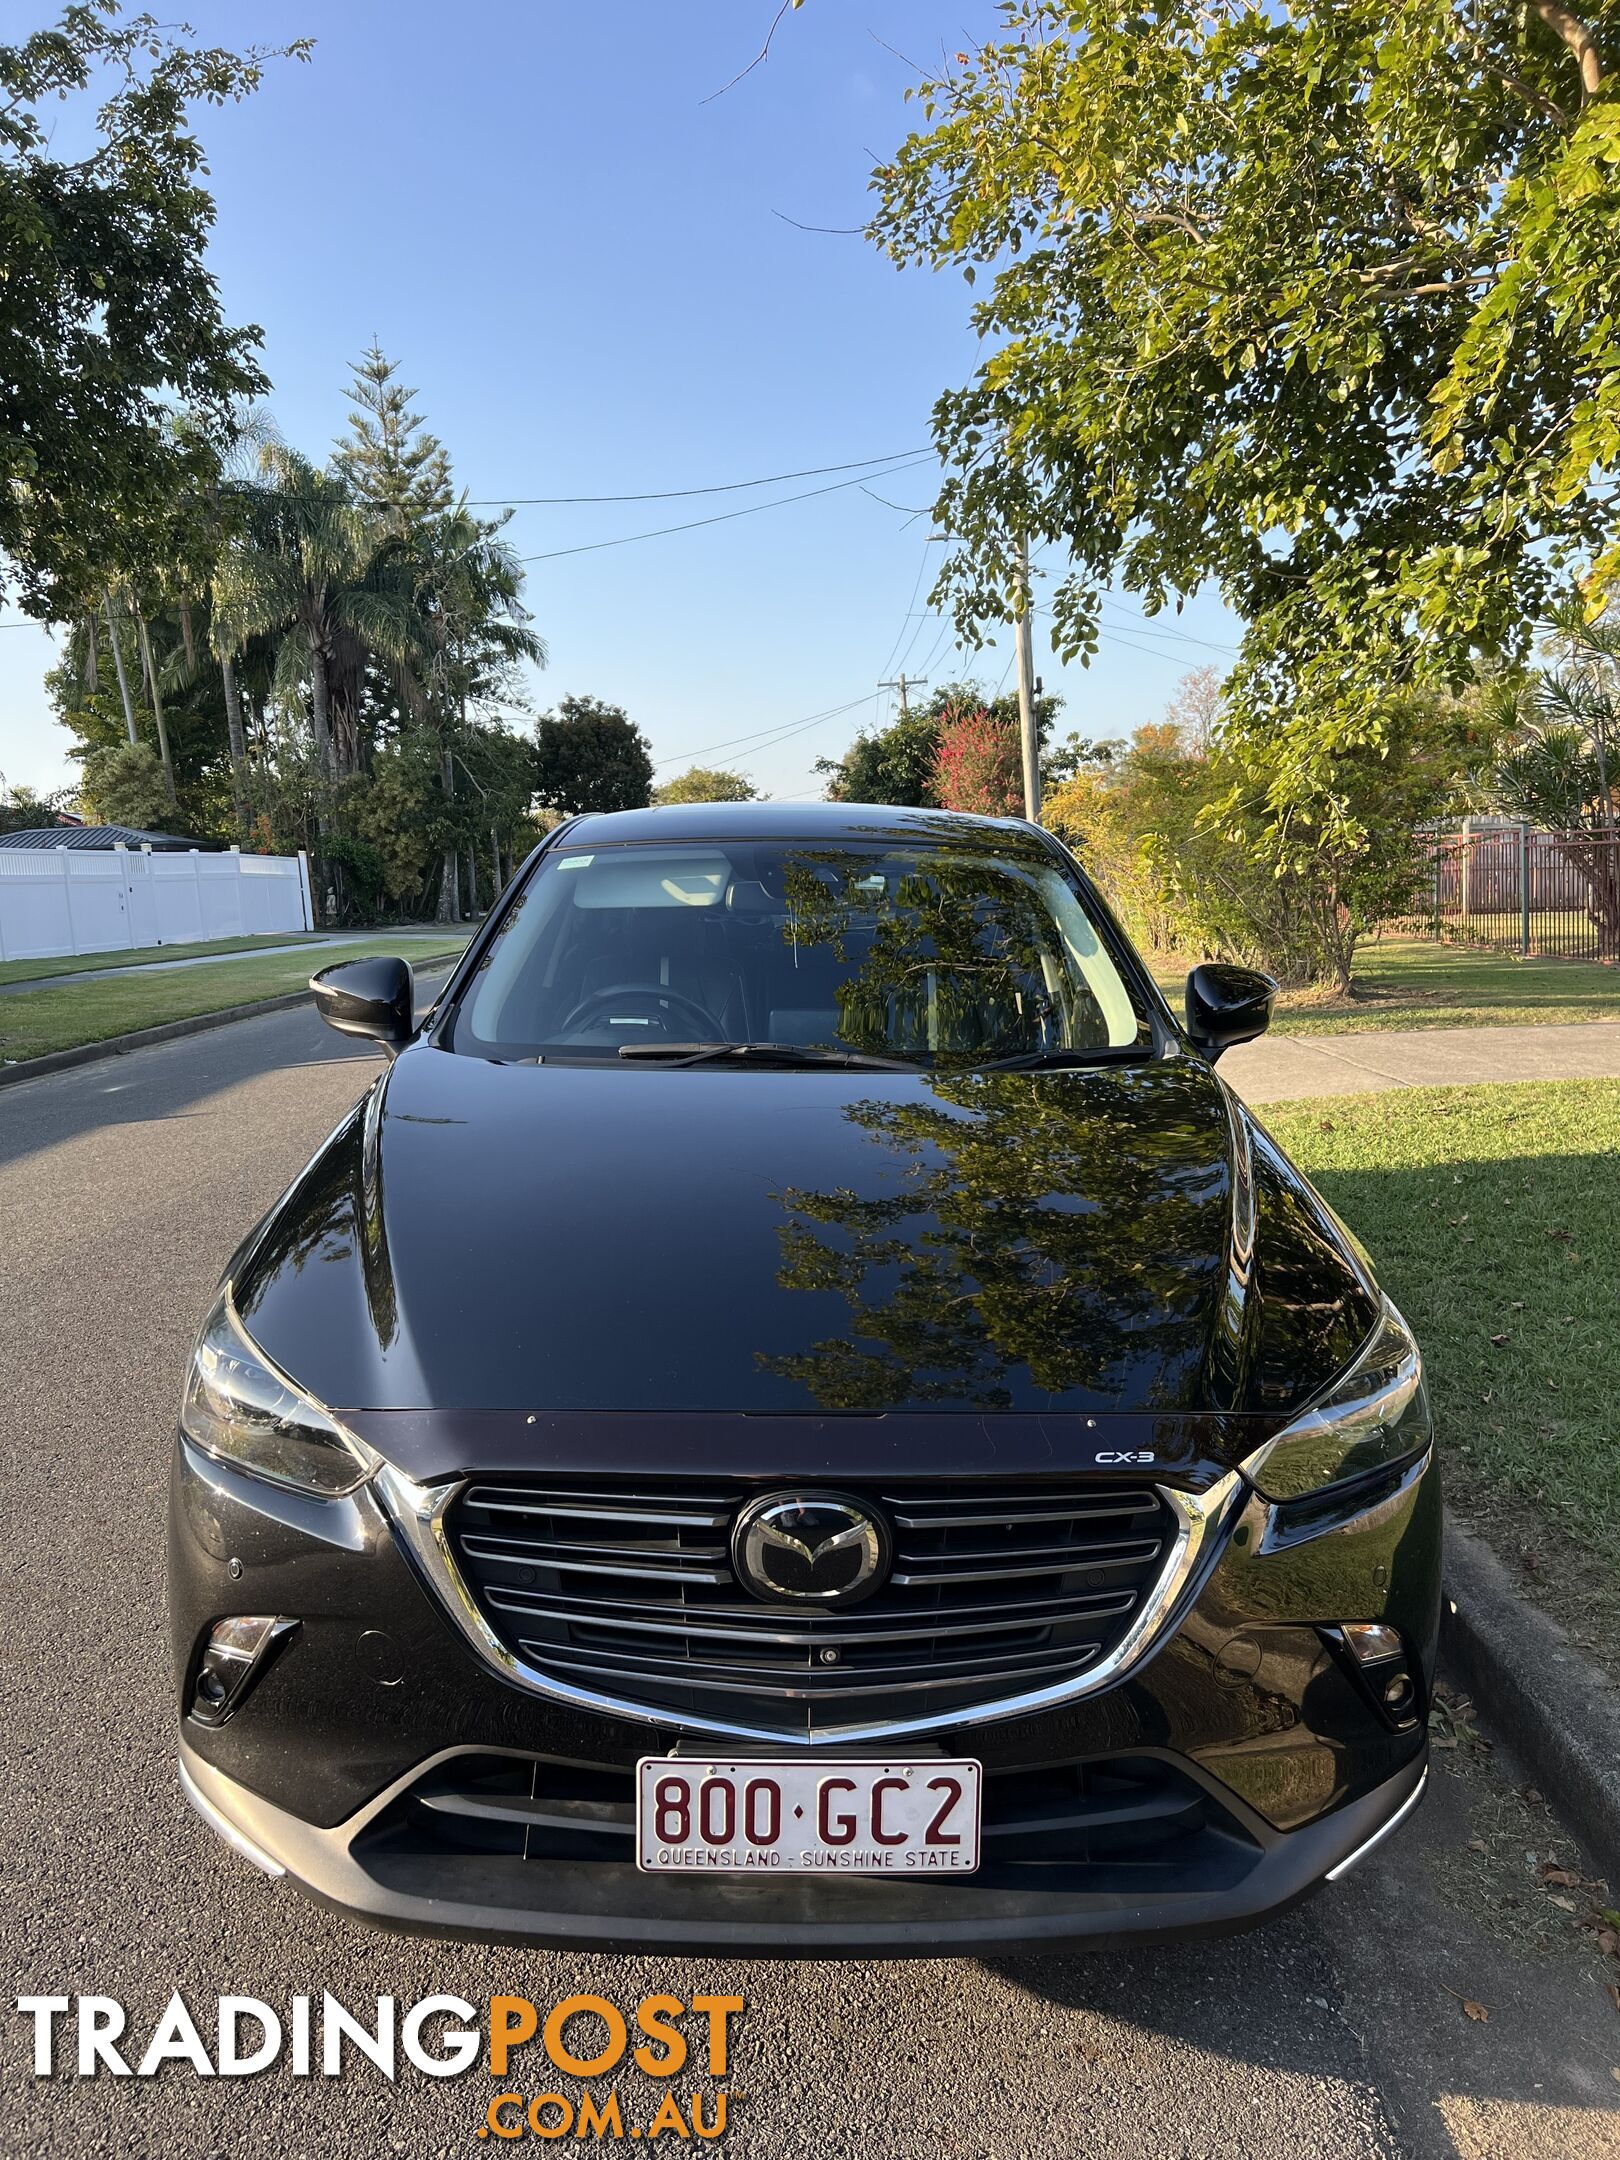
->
xmin=0 ymin=929 xmax=467 ymax=1061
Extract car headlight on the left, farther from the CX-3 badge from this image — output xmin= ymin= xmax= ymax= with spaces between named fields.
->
xmin=179 ymin=1290 xmax=376 ymax=1495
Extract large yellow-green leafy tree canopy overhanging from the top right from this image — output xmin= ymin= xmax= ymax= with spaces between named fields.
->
xmin=873 ymin=0 xmax=1620 ymax=743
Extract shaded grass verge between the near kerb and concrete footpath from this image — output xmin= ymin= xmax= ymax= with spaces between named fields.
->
xmin=1261 ymin=1080 xmax=1620 ymax=1670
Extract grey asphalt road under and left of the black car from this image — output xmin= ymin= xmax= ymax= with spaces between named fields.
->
xmin=0 ymin=1009 xmax=1620 ymax=2160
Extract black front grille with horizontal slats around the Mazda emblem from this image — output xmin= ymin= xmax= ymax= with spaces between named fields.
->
xmin=445 ymin=1480 xmax=1177 ymax=1732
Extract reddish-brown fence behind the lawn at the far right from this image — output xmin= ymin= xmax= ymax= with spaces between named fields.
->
xmin=1419 ymin=819 xmax=1620 ymax=961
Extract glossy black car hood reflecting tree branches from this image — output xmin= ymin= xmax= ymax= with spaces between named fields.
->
xmin=233 ymin=1043 xmax=1374 ymax=1428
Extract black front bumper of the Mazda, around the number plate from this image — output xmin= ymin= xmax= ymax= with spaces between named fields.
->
xmin=168 ymin=1441 xmax=1441 ymax=1957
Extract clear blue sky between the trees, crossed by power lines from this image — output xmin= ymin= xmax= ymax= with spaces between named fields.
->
xmin=0 ymin=0 xmax=1236 ymax=797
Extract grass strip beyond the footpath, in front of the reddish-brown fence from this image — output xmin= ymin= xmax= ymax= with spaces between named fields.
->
xmin=1153 ymin=937 xmax=1620 ymax=1035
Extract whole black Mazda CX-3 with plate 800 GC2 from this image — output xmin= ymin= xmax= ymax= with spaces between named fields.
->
xmin=168 ymin=804 xmax=1441 ymax=1955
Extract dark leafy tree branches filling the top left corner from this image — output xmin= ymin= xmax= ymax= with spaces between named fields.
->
xmin=0 ymin=0 xmax=309 ymax=622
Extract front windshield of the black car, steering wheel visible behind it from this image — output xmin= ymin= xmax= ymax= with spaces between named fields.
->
xmin=451 ymin=840 xmax=1149 ymax=1069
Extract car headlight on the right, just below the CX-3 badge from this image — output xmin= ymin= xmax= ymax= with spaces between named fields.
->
xmin=1244 ymin=1298 xmax=1432 ymax=1499
